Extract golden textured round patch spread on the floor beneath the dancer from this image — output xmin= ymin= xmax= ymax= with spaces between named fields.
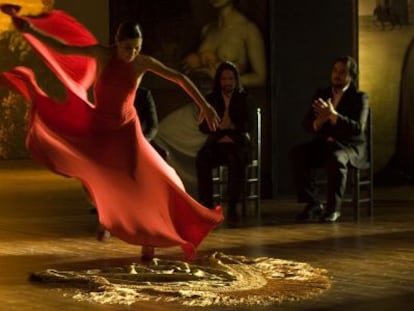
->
xmin=32 ymin=253 xmax=331 ymax=306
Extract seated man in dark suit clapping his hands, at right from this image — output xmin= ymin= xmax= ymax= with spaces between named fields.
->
xmin=290 ymin=56 xmax=369 ymax=222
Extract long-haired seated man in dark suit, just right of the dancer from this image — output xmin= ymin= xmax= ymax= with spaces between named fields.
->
xmin=196 ymin=62 xmax=250 ymax=217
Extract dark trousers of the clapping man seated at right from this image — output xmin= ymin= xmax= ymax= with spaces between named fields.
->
xmin=290 ymin=140 xmax=353 ymax=212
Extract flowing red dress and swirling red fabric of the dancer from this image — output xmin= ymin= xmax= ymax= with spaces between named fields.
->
xmin=0 ymin=6 xmax=223 ymax=259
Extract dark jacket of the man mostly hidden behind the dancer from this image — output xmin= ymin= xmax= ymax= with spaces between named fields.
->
xmin=134 ymin=87 xmax=158 ymax=141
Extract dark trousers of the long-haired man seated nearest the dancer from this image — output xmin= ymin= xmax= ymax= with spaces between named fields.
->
xmin=196 ymin=143 xmax=247 ymax=209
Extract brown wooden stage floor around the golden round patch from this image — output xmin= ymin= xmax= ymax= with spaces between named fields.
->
xmin=0 ymin=161 xmax=414 ymax=311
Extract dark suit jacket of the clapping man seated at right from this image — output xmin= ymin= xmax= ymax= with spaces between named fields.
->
xmin=303 ymin=84 xmax=369 ymax=166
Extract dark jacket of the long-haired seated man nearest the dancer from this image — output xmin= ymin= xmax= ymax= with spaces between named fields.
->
xmin=199 ymin=92 xmax=252 ymax=146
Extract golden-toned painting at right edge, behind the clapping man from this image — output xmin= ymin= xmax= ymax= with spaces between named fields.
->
xmin=359 ymin=0 xmax=414 ymax=184
